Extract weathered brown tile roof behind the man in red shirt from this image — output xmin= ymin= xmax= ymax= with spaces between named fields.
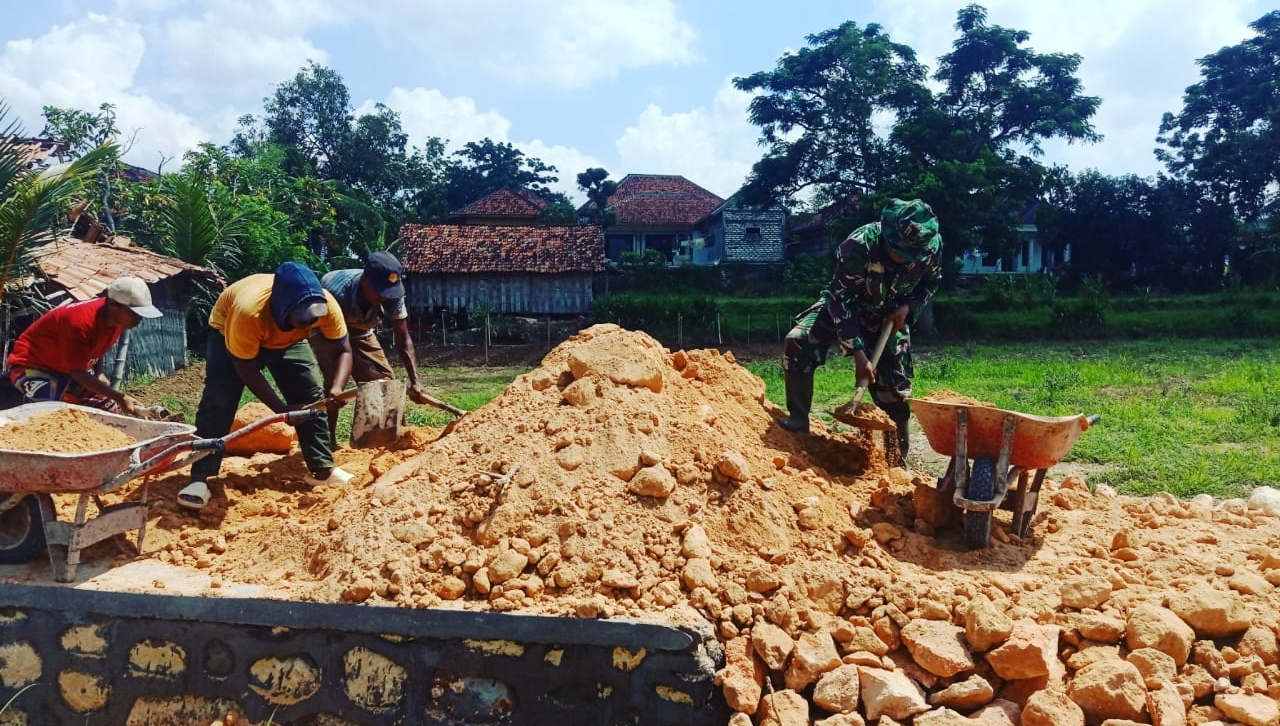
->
xmin=32 ymin=237 xmax=225 ymax=300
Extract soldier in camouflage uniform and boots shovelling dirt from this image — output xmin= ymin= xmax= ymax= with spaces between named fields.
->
xmin=782 ymin=200 xmax=942 ymax=462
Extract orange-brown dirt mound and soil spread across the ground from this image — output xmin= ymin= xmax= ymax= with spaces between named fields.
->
xmin=2 ymin=325 xmax=1280 ymax=726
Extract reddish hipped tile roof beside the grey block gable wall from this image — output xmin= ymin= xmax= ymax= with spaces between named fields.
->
xmin=582 ymin=174 xmax=724 ymax=227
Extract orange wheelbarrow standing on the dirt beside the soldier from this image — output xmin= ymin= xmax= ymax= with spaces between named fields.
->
xmin=909 ymin=398 xmax=1098 ymax=549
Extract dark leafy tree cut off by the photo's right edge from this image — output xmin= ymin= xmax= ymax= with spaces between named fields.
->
xmin=1156 ymin=10 xmax=1280 ymax=220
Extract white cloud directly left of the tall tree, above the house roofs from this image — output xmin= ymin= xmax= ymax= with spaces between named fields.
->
xmin=616 ymin=79 xmax=760 ymax=197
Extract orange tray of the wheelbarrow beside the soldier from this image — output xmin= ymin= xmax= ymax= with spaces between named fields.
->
xmin=910 ymin=398 xmax=1089 ymax=469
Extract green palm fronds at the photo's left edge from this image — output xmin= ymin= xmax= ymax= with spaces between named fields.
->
xmin=0 ymin=101 xmax=118 ymax=302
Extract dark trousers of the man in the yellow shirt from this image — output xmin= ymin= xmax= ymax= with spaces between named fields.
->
xmin=191 ymin=330 xmax=333 ymax=481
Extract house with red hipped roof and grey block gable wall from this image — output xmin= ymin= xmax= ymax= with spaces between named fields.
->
xmin=579 ymin=174 xmax=786 ymax=265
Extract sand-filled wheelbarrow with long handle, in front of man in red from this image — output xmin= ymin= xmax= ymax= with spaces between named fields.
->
xmin=0 ymin=402 xmax=320 ymax=583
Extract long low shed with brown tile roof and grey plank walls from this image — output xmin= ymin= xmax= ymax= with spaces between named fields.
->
xmin=401 ymin=224 xmax=605 ymax=316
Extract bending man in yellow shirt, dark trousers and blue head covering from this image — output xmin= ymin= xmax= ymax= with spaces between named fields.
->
xmin=178 ymin=262 xmax=353 ymax=508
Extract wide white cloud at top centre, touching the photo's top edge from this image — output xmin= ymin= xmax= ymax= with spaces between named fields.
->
xmin=364 ymin=0 xmax=699 ymax=88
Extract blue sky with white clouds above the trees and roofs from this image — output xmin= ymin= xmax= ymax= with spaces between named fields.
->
xmin=0 ymin=0 xmax=1274 ymax=201
